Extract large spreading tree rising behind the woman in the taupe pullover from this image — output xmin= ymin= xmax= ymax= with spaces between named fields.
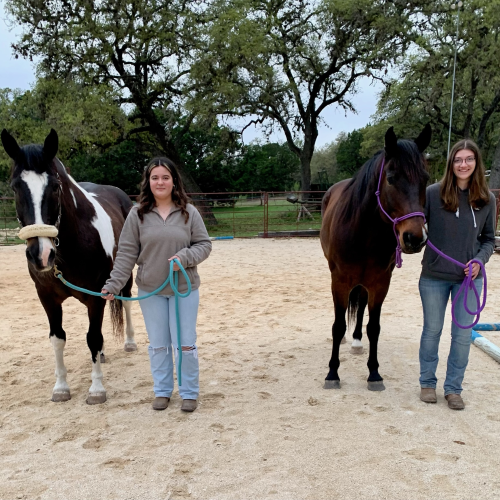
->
xmin=5 ymin=0 xmax=212 ymax=192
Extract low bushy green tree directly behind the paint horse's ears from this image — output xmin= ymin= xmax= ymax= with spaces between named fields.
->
xmin=0 ymin=79 xmax=130 ymax=187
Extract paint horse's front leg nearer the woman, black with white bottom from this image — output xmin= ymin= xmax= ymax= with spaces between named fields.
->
xmin=87 ymin=298 xmax=106 ymax=405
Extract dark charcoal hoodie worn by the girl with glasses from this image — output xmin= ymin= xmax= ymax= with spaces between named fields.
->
xmin=422 ymin=183 xmax=496 ymax=283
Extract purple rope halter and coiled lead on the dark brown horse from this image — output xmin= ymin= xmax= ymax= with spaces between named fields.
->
xmin=375 ymin=157 xmax=487 ymax=330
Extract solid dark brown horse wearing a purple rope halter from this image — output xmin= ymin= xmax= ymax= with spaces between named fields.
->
xmin=321 ymin=125 xmax=431 ymax=391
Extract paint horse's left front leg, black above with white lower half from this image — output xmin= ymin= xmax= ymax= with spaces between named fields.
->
xmin=38 ymin=292 xmax=71 ymax=403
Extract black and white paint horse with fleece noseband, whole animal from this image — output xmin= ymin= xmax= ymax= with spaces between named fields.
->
xmin=1 ymin=129 xmax=137 ymax=404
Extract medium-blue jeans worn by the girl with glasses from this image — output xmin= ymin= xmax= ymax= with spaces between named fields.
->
xmin=418 ymin=276 xmax=483 ymax=396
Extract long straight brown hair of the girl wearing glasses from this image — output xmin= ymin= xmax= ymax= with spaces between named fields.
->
xmin=440 ymin=139 xmax=490 ymax=212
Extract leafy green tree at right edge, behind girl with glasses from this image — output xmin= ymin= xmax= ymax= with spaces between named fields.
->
xmin=363 ymin=0 xmax=500 ymax=187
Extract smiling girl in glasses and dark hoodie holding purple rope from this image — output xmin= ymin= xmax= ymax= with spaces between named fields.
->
xmin=419 ymin=139 xmax=496 ymax=410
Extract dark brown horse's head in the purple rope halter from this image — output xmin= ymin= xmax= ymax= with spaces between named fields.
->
xmin=379 ymin=124 xmax=432 ymax=253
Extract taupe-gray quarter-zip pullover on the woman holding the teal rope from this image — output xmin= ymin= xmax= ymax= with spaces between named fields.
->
xmin=103 ymin=204 xmax=212 ymax=295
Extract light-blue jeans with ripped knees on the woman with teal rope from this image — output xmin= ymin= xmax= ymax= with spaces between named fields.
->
xmin=138 ymin=290 xmax=200 ymax=399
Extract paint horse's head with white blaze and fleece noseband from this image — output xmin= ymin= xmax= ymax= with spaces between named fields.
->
xmin=1 ymin=129 xmax=61 ymax=271
